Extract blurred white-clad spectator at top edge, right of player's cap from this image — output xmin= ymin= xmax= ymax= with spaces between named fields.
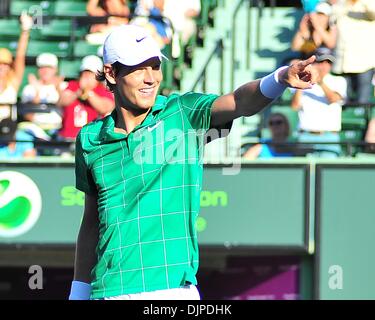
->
xmin=164 ymin=0 xmax=201 ymax=45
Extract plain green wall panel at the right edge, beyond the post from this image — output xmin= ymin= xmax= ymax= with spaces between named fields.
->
xmin=316 ymin=165 xmax=375 ymax=300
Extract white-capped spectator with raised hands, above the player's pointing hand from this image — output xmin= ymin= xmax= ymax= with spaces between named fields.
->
xmin=292 ymin=2 xmax=337 ymax=58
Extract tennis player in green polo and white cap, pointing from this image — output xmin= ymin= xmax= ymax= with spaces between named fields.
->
xmin=69 ymin=25 xmax=315 ymax=300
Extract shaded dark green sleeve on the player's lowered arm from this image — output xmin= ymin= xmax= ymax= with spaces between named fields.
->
xmin=75 ymin=134 xmax=97 ymax=194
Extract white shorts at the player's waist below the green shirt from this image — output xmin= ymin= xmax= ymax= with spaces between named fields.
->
xmin=104 ymin=284 xmax=201 ymax=300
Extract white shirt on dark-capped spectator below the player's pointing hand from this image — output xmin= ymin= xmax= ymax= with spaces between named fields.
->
xmin=298 ymin=74 xmax=347 ymax=132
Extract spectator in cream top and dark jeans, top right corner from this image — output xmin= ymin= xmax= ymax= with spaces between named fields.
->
xmin=333 ymin=0 xmax=375 ymax=103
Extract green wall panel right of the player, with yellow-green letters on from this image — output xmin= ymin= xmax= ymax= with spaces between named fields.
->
xmin=198 ymin=165 xmax=306 ymax=247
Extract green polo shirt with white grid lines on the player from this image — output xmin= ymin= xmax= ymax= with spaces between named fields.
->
xmin=76 ymin=93 xmax=217 ymax=299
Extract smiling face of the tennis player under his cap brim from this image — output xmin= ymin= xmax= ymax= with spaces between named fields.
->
xmin=115 ymin=58 xmax=163 ymax=113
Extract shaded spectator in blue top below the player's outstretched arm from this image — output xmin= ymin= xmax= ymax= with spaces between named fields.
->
xmin=243 ymin=113 xmax=293 ymax=160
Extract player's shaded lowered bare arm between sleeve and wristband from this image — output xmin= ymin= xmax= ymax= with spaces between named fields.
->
xmin=74 ymin=193 xmax=99 ymax=283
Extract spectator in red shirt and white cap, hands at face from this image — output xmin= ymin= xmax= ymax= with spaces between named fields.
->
xmin=57 ymin=56 xmax=114 ymax=140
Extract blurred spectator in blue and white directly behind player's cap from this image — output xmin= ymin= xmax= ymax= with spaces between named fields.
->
xmin=131 ymin=0 xmax=172 ymax=49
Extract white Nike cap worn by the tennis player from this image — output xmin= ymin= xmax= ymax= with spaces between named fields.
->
xmin=103 ymin=25 xmax=166 ymax=66
